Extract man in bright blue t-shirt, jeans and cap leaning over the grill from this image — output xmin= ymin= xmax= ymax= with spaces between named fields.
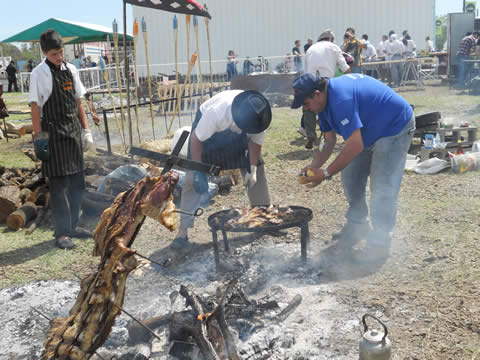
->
xmin=292 ymin=74 xmax=415 ymax=261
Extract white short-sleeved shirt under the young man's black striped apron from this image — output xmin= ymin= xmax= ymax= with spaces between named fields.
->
xmin=28 ymin=60 xmax=87 ymax=116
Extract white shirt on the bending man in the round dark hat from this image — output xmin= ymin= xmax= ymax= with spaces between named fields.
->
xmin=195 ymin=90 xmax=265 ymax=145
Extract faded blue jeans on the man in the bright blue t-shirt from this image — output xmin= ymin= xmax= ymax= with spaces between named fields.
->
xmin=342 ymin=116 xmax=415 ymax=243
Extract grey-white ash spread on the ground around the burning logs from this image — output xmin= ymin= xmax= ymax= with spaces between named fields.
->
xmin=0 ymin=233 xmax=365 ymax=360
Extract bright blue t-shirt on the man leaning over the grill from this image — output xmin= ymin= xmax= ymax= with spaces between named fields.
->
xmin=318 ymin=74 xmax=413 ymax=147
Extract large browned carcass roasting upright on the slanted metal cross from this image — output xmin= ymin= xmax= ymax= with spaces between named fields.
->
xmin=42 ymin=172 xmax=178 ymax=360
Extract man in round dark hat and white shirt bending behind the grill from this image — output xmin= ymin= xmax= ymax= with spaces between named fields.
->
xmin=172 ymin=90 xmax=272 ymax=248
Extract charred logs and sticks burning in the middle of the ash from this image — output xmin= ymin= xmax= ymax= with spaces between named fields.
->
xmin=125 ymin=279 xmax=302 ymax=360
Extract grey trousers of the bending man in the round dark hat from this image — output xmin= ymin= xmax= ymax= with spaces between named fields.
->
xmin=180 ymin=158 xmax=270 ymax=229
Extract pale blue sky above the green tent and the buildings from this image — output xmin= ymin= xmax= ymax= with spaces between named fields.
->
xmin=0 ymin=0 xmax=468 ymax=41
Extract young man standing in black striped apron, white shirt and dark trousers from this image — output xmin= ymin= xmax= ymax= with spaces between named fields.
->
xmin=29 ymin=30 xmax=93 ymax=249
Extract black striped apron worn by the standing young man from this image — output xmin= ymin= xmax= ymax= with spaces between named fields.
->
xmin=41 ymin=63 xmax=83 ymax=177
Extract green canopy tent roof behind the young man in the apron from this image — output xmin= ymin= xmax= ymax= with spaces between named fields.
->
xmin=1 ymin=18 xmax=133 ymax=44
